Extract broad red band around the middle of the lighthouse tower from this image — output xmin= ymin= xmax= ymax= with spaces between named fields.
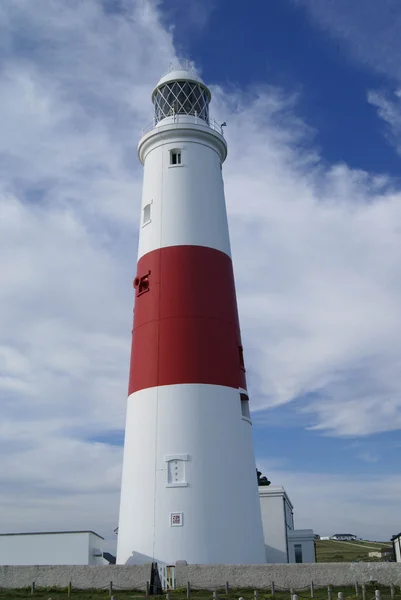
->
xmin=129 ymin=246 xmax=246 ymax=394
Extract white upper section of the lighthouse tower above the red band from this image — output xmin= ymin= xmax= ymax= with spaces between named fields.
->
xmin=138 ymin=115 xmax=231 ymax=260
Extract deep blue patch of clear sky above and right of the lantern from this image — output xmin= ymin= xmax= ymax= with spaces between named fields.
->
xmin=164 ymin=0 xmax=400 ymax=176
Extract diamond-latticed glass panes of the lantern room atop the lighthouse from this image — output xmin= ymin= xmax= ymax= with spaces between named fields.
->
xmin=154 ymin=81 xmax=209 ymax=123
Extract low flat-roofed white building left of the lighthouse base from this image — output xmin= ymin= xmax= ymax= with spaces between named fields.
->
xmin=0 ymin=531 xmax=108 ymax=565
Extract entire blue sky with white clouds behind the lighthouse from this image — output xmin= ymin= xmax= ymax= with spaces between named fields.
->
xmin=0 ymin=0 xmax=401 ymax=547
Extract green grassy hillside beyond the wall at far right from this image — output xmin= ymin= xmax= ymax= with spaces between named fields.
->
xmin=316 ymin=540 xmax=392 ymax=562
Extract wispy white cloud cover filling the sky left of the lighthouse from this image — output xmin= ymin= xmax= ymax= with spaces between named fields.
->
xmin=0 ymin=0 xmax=174 ymax=535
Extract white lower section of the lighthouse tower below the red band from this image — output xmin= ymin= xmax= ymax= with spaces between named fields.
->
xmin=117 ymin=384 xmax=265 ymax=564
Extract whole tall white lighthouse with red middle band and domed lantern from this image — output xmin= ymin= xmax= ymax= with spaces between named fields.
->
xmin=117 ymin=61 xmax=266 ymax=564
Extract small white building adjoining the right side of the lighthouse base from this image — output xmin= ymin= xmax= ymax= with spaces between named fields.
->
xmin=259 ymin=486 xmax=316 ymax=563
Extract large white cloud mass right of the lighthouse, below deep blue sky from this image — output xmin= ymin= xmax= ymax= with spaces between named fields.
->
xmin=212 ymin=85 xmax=401 ymax=435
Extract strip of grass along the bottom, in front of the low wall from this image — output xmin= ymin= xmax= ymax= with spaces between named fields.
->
xmin=0 ymin=583 xmax=401 ymax=600
